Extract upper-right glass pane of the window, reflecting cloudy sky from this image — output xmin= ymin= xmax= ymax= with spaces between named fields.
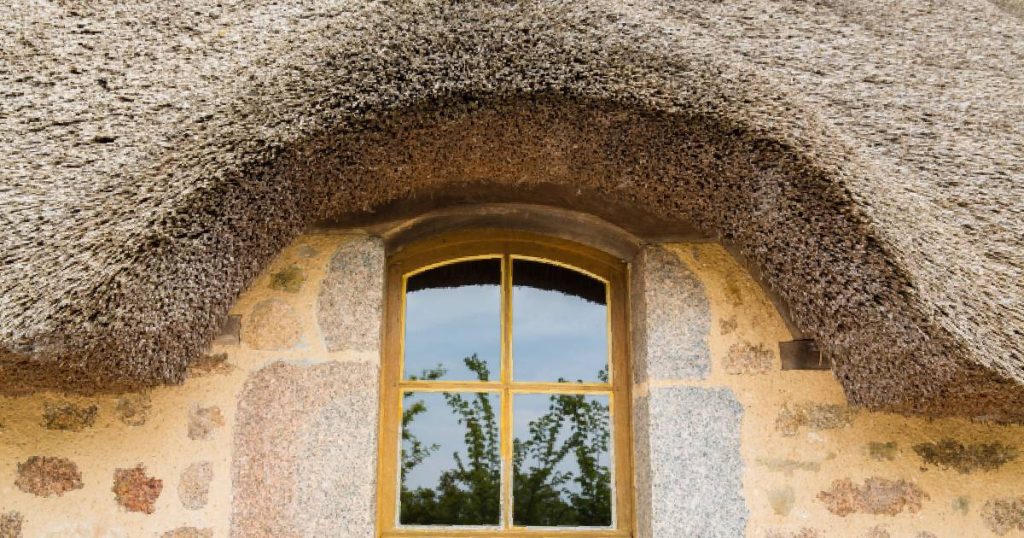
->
xmin=512 ymin=259 xmax=608 ymax=382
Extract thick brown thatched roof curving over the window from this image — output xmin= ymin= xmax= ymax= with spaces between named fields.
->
xmin=0 ymin=0 xmax=1024 ymax=420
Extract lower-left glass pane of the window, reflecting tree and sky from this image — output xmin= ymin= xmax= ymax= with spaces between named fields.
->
xmin=398 ymin=392 xmax=502 ymax=526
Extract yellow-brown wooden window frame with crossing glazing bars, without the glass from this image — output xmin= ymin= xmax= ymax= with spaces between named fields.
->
xmin=376 ymin=231 xmax=635 ymax=538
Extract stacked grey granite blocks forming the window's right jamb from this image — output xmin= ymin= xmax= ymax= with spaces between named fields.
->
xmin=630 ymin=246 xmax=748 ymax=538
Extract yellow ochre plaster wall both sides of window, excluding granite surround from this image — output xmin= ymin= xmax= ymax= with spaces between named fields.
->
xmin=0 ymin=233 xmax=1024 ymax=538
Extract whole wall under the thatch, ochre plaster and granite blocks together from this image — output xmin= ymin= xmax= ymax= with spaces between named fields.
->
xmin=0 ymin=234 xmax=1024 ymax=538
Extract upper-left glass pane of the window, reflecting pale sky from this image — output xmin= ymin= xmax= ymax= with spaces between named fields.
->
xmin=402 ymin=258 xmax=502 ymax=381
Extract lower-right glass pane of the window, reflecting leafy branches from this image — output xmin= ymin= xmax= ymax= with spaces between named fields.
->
xmin=512 ymin=395 xmax=612 ymax=527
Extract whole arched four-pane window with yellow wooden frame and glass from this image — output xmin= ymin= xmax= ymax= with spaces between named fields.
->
xmin=378 ymin=232 xmax=633 ymax=537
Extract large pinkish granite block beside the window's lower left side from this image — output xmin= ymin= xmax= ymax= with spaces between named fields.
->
xmin=231 ymin=362 xmax=378 ymax=538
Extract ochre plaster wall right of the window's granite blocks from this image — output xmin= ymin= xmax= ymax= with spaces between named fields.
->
xmin=659 ymin=244 xmax=1024 ymax=538
